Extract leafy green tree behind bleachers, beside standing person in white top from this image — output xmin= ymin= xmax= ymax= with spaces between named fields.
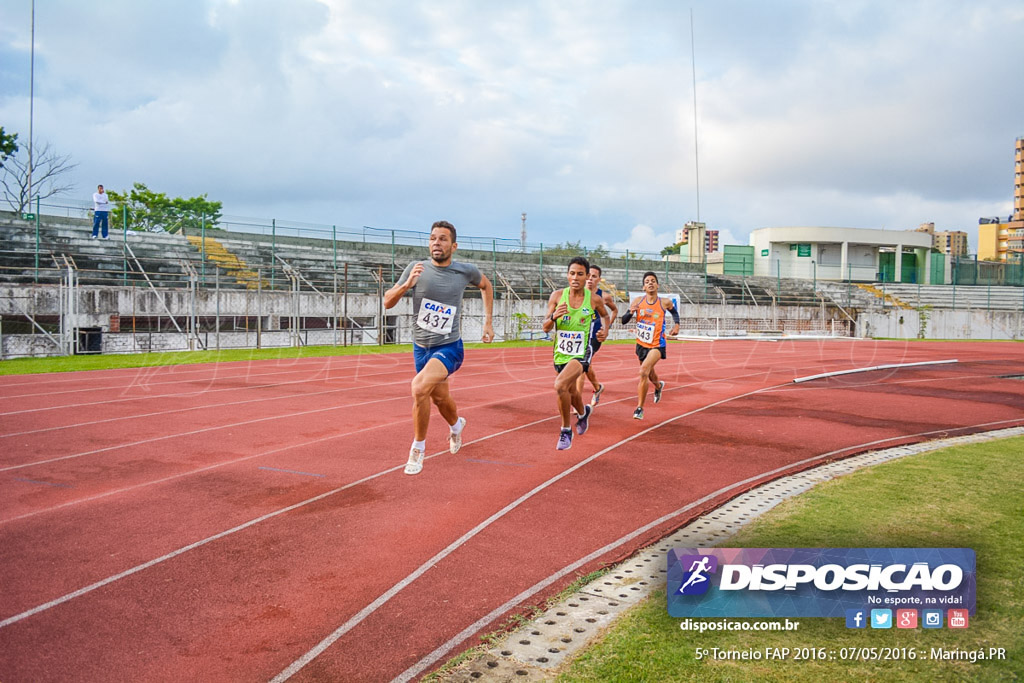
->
xmin=108 ymin=182 xmax=221 ymax=232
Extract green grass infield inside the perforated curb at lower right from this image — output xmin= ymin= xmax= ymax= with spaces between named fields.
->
xmin=559 ymin=437 xmax=1024 ymax=683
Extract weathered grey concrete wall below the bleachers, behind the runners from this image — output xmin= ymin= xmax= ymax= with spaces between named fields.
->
xmin=0 ymin=286 xmax=856 ymax=358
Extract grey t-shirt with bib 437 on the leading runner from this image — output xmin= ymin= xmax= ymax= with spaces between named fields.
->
xmin=398 ymin=259 xmax=482 ymax=348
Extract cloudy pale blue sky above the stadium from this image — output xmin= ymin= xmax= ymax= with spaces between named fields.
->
xmin=0 ymin=0 xmax=1024 ymax=251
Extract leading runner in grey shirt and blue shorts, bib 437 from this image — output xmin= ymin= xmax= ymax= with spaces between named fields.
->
xmin=384 ymin=220 xmax=495 ymax=474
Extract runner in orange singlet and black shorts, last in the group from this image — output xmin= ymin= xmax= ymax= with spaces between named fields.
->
xmin=623 ymin=270 xmax=679 ymax=420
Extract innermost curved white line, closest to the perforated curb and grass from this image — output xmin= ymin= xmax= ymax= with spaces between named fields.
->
xmin=393 ymin=420 xmax=1019 ymax=683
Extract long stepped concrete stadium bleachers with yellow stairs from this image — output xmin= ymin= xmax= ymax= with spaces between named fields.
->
xmin=0 ymin=212 xmax=1024 ymax=314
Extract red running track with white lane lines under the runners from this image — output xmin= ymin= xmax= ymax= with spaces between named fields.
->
xmin=0 ymin=340 xmax=1024 ymax=682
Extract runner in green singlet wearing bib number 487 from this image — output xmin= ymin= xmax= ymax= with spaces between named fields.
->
xmin=543 ymin=256 xmax=611 ymax=451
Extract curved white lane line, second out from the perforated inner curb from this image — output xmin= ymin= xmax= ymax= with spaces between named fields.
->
xmin=270 ymin=387 xmax=769 ymax=683
